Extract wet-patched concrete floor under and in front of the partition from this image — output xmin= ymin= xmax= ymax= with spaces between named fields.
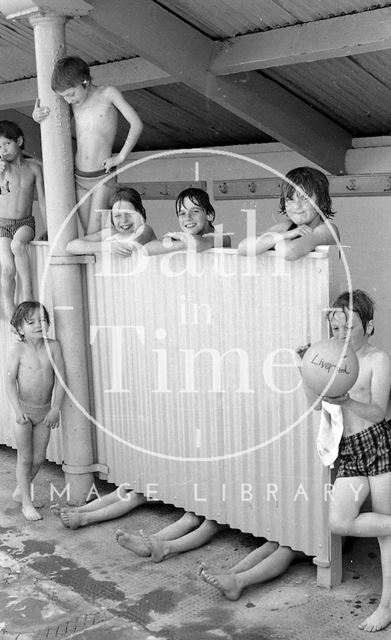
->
xmin=0 ymin=446 xmax=390 ymax=640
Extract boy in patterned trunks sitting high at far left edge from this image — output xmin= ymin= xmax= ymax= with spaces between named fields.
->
xmin=0 ymin=120 xmax=46 ymax=319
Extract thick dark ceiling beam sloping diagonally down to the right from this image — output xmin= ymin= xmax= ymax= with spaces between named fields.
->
xmin=89 ymin=0 xmax=352 ymax=174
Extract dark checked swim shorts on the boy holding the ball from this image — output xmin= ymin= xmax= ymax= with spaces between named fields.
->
xmin=337 ymin=419 xmax=391 ymax=478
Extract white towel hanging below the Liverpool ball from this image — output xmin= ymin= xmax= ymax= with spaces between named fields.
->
xmin=316 ymin=400 xmax=343 ymax=467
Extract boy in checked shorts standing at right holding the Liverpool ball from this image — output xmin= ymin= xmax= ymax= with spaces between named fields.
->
xmin=305 ymin=289 xmax=391 ymax=631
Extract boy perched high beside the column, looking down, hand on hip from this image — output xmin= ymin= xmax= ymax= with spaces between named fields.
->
xmin=33 ymin=56 xmax=142 ymax=234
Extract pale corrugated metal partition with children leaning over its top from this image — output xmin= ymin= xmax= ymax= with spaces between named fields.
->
xmin=87 ymin=251 xmax=329 ymax=559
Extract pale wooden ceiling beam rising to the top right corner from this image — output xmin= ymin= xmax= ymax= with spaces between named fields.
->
xmin=209 ymin=8 xmax=391 ymax=75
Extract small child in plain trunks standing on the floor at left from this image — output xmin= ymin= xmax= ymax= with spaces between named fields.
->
xmin=7 ymin=301 xmax=65 ymax=520
